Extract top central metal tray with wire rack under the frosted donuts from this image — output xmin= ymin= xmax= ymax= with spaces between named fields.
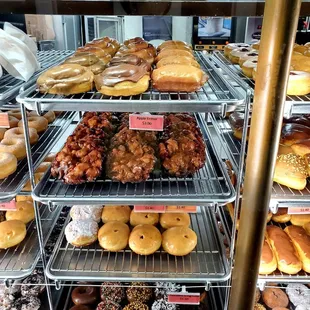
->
xmin=17 ymin=52 xmax=244 ymax=113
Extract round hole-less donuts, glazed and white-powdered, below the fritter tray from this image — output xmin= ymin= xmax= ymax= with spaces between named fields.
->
xmin=65 ymin=206 xmax=197 ymax=256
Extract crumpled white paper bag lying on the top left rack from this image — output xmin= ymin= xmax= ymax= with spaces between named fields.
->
xmin=0 ymin=29 xmax=40 ymax=82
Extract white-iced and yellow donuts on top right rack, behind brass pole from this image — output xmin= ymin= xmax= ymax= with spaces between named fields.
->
xmin=224 ymin=43 xmax=310 ymax=96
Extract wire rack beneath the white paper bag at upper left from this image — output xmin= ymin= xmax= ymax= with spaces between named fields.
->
xmin=0 ymin=50 xmax=73 ymax=102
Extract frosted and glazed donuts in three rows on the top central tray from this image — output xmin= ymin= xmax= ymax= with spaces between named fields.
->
xmin=37 ymin=37 xmax=208 ymax=96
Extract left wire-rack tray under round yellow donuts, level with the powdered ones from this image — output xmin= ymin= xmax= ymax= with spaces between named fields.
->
xmin=0 ymin=206 xmax=61 ymax=279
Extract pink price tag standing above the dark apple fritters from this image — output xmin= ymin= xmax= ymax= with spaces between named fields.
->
xmin=129 ymin=114 xmax=164 ymax=131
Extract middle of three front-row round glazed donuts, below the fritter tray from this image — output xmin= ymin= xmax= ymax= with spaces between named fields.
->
xmin=129 ymin=225 xmax=161 ymax=255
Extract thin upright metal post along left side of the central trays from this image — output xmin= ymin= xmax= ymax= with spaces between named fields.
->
xmin=20 ymin=103 xmax=53 ymax=310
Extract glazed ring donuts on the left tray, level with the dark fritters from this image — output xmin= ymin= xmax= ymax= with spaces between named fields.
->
xmin=0 ymin=110 xmax=55 ymax=179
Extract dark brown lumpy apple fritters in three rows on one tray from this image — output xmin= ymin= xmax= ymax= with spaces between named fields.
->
xmin=51 ymin=112 xmax=206 ymax=184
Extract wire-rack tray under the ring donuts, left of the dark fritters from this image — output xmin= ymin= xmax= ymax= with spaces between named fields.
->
xmin=0 ymin=112 xmax=76 ymax=201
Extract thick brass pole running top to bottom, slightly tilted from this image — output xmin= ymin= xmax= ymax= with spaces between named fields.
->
xmin=228 ymin=0 xmax=301 ymax=310
